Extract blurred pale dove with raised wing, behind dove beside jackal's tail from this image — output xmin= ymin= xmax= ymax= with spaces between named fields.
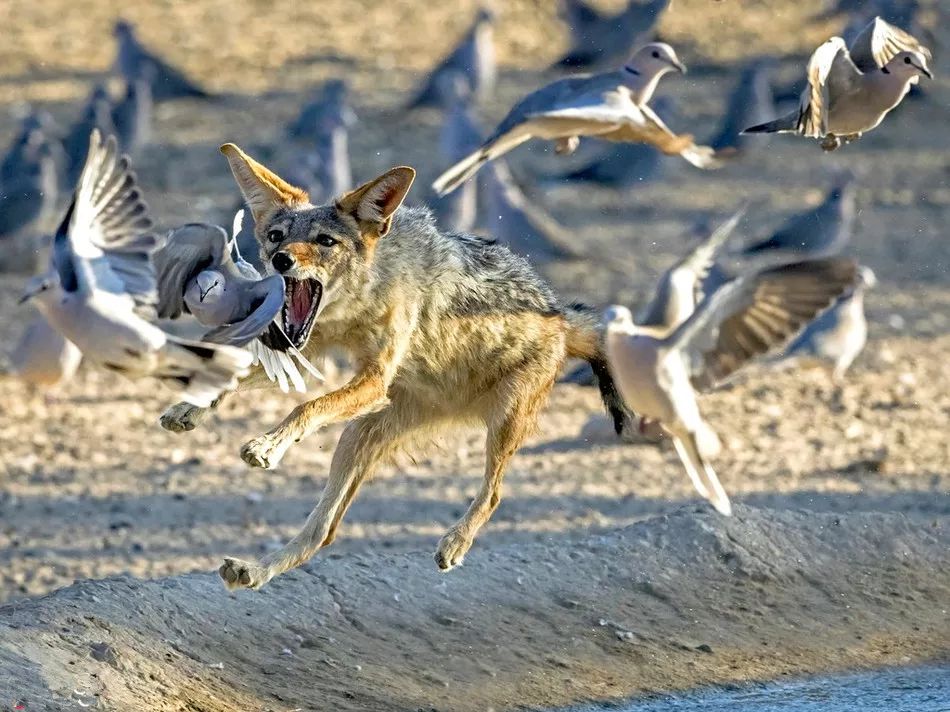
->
xmin=636 ymin=205 xmax=746 ymax=329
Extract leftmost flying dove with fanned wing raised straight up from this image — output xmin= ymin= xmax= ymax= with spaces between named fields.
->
xmin=20 ymin=130 xmax=252 ymax=407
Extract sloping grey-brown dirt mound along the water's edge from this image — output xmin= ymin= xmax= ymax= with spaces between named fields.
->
xmin=0 ymin=507 xmax=950 ymax=712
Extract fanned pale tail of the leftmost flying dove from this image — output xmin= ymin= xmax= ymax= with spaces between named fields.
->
xmin=162 ymin=335 xmax=253 ymax=408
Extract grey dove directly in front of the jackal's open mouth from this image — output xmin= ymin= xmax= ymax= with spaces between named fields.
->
xmin=154 ymin=211 xmax=323 ymax=393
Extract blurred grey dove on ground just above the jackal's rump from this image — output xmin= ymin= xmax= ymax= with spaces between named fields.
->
xmin=480 ymin=161 xmax=581 ymax=265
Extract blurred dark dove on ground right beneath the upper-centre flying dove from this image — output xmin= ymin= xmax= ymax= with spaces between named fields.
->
xmin=544 ymin=96 xmax=676 ymax=188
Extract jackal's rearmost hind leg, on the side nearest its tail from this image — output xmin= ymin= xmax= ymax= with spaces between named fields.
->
xmin=435 ymin=363 xmax=558 ymax=571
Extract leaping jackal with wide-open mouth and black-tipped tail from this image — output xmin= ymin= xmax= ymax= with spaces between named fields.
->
xmin=162 ymin=144 xmax=625 ymax=588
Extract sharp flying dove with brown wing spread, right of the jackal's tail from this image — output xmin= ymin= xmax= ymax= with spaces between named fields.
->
xmin=603 ymin=259 xmax=857 ymax=515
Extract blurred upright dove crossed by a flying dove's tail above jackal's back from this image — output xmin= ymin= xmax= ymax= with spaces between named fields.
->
xmin=428 ymin=72 xmax=482 ymax=232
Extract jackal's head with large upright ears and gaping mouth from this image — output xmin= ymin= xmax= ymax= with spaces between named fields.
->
xmin=221 ymin=143 xmax=416 ymax=348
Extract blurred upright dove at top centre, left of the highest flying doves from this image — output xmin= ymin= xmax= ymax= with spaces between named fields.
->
xmin=407 ymin=7 xmax=496 ymax=109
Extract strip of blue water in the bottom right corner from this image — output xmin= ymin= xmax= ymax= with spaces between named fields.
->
xmin=572 ymin=665 xmax=950 ymax=712
